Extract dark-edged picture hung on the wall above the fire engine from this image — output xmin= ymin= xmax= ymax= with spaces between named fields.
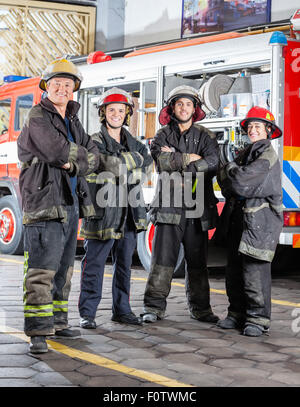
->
xmin=181 ymin=0 xmax=271 ymax=37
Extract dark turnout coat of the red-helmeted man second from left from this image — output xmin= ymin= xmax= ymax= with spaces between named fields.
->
xmin=80 ymin=124 xmax=152 ymax=240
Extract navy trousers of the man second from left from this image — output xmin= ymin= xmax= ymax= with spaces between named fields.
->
xmin=78 ymin=222 xmax=136 ymax=319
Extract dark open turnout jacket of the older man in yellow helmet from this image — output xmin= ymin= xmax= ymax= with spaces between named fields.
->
xmin=17 ymin=98 xmax=99 ymax=224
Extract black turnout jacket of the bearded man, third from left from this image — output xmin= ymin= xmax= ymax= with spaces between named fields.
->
xmin=150 ymin=120 xmax=219 ymax=231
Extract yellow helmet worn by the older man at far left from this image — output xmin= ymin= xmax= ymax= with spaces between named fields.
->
xmin=39 ymin=58 xmax=82 ymax=92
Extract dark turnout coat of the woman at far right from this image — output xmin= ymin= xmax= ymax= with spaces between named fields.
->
xmin=218 ymin=139 xmax=283 ymax=262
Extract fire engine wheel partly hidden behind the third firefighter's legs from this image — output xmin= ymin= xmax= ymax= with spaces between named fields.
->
xmin=137 ymin=222 xmax=185 ymax=277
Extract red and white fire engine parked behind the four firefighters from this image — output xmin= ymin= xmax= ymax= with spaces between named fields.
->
xmin=0 ymin=10 xmax=300 ymax=269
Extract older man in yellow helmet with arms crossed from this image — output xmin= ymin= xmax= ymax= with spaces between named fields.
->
xmin=18 ymin=58 xmax=99 ymax=353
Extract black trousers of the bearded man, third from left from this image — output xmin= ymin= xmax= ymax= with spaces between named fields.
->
xmin=144 ymin=215 xmax=212 ymax=319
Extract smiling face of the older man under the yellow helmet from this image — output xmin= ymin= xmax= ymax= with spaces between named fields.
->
xmin=47 ymin=77 xmax=75 ymax=106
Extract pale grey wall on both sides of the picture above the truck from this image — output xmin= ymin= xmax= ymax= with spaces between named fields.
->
xmin=96 ymin=0 xmax=300 ymax=51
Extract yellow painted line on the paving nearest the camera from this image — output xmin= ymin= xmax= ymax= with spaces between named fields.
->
xmin=0 ymin=326 xmax=194 ymax=387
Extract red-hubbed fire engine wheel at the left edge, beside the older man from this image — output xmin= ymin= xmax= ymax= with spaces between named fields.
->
xmin=0 ymin=195 xmax=23 ymax=254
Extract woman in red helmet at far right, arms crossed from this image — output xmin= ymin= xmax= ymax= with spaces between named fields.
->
xmin=218 ymin=106 xmax=283 ymax=336
